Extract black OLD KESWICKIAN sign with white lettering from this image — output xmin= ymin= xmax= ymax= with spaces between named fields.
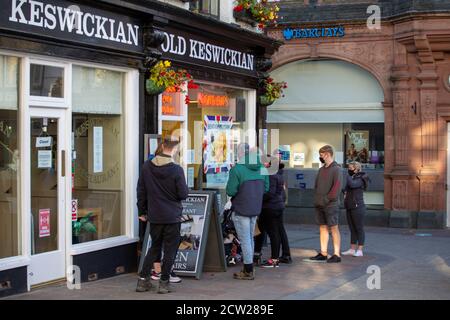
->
xmin=160 ymin=31 xmax=255 ymax=72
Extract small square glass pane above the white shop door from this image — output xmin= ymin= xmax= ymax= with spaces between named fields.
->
xmin=30 ymin=64 xmax=64 ymax=98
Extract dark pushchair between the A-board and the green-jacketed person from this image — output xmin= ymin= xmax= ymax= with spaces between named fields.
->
xmin=222 ymin=209 xmax=242 ymax=267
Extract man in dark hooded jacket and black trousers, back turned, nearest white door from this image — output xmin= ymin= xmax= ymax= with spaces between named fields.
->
xmin=136 ymin=139 xmax=189 ymax=293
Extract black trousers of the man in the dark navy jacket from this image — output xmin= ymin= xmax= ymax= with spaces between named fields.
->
xmin=141 ymin=223 xmax=181 ymax=281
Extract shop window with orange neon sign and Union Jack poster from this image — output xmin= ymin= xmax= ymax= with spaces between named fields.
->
xmin=185 ymin=84 xmax=248 ymax=189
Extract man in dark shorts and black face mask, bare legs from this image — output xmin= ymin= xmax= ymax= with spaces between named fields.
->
xmin=310 ymin=145 xmax=342 ymax=263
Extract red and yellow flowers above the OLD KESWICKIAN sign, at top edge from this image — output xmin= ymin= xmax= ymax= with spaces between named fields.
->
xmin=233 ymin=0 xmax=280 ymax=29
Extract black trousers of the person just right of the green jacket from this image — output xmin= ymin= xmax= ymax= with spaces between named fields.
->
xmin=255 ymin=209 xmax=290 ymax=259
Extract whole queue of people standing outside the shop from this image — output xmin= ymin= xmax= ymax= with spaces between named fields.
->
xmin=136 ymin=139 xmax=368 ymax=293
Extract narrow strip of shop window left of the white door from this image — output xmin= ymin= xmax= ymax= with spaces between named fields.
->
xmin=0 ymin=55 xmax=20 ymax=259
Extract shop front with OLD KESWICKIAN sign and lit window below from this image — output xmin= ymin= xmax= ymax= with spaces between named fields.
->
xmin=148 ymin=21 xmax=280 ymax=195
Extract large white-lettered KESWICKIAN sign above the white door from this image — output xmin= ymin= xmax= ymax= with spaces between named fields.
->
xmin=0 ymin=0 xmax=143 ymax=51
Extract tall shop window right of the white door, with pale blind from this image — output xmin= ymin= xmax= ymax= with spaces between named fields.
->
xmin=72 ymin=66 xmax=125 ymax=244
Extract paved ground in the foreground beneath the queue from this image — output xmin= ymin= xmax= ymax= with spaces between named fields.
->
xmin=5 ymin=225 xmax=450 ymax=300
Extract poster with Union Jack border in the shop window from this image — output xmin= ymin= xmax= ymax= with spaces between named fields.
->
xmin=203 ymin=115 xmax=233 ymax=173
